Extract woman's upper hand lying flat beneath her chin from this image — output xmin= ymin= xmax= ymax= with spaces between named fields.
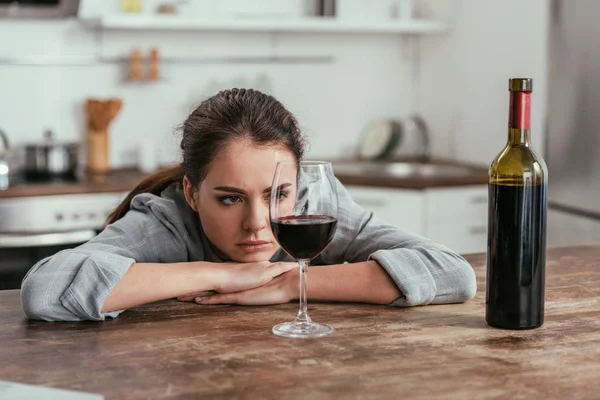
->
xmin=177 ymin=261 xmax=298 ymax=301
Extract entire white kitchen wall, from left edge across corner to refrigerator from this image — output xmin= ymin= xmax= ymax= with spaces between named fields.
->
xmin=0 ymin=0 xmax=548 ymax=167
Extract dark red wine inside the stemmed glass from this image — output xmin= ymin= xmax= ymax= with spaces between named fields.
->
xmin=271 ymin=215 xmax=337 ymax=260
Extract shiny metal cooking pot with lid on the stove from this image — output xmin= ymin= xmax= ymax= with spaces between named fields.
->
xmin=24 ymin=131 xmax=79 ymax=179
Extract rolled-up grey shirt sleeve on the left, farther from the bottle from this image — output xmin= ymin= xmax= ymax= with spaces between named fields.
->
xmin=21 ymin=194 xmax=187 ymax=321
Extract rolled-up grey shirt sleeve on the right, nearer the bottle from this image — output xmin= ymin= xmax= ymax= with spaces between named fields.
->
xmin=320 ymin=181 xmax=477 ymax=307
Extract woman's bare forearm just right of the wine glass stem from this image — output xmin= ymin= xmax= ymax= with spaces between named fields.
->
xmin=307 ymin=261 xmax=402 ymax=304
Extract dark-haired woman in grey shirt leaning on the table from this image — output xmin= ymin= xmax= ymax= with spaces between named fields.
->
xmin=21 ymin=89 xmax=476 ymax=321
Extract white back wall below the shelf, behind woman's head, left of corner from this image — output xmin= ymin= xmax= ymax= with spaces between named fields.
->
xmin=0 ymin=2 xmax=413 ymax=167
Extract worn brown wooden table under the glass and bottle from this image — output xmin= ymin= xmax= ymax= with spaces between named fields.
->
xmin=0 ymin=246 xmax=600 ymax=399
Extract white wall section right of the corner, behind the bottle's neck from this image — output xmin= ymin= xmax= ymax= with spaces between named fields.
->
xmin=415 ymin=0 xmax=549 ymax=166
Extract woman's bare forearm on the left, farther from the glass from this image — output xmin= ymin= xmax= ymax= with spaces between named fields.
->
xmin=102 ymin=262 xmax=216 ymax=313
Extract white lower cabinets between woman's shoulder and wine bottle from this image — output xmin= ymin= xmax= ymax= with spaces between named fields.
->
xmin=348 ymin=185 xmax=488 ymax=254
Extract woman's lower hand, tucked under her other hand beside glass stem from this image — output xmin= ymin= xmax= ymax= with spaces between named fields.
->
xmin=195 ymin=263 xmax=300 ymax=306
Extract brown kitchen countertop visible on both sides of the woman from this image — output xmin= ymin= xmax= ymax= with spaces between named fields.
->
xmin=0 ymin=161 xmax=488 ymax=199
